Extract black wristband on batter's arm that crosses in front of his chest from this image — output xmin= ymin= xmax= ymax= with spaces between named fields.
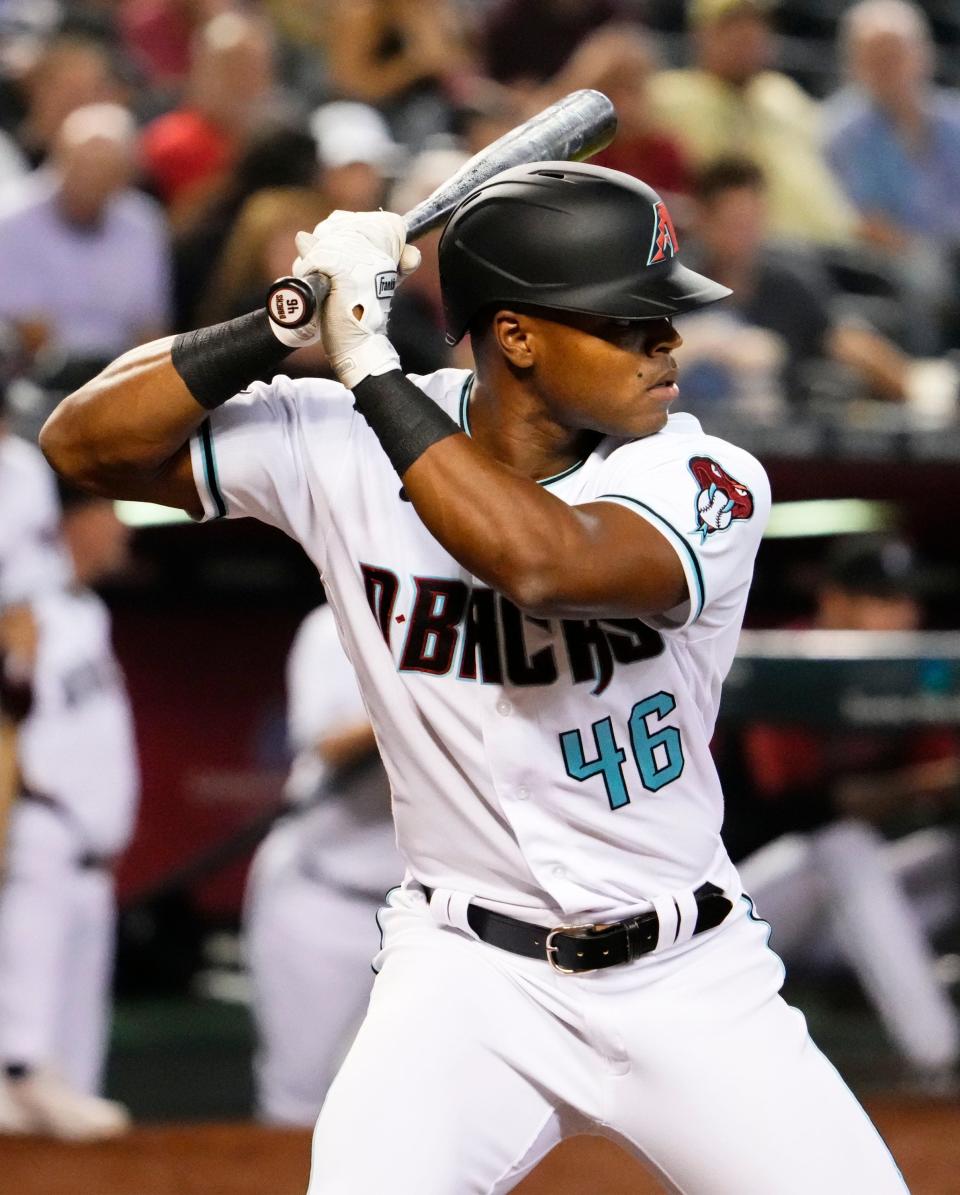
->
xmin=354 ymin=369 xmax=460 ymax=477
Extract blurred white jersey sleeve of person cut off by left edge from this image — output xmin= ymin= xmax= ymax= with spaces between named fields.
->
xmin=0 ymin=434 xmax=73 ymax=606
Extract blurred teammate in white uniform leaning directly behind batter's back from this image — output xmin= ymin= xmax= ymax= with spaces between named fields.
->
xmin=244 ymin=606 xmax=404 ymax=1127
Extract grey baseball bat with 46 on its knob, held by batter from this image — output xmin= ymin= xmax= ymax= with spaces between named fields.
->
xmin=267 ymin=87 xmax=617 ymax=329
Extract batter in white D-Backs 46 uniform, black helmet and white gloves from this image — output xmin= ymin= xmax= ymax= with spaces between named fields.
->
xmin=42 ymin=163 xmax=905 ymax=1195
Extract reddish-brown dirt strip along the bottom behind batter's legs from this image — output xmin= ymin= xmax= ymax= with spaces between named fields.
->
xmin=0 ymin=1099 xmax=960 ymax=1195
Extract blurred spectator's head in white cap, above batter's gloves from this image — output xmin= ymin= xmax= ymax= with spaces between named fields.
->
xmin=310 ymin=100 xmax=404 ymax=212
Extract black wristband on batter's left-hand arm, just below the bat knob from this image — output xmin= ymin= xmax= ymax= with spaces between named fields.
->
xmin=170 ymin=311 xmax=293 ymax=411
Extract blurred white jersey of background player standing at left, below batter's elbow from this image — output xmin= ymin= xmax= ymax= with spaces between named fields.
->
xmin=18 ymin=589 xmax=140 ymax=856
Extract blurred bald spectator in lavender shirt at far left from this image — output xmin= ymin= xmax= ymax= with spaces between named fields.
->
xmin=0 ymin=104 xmax=170 ymax=378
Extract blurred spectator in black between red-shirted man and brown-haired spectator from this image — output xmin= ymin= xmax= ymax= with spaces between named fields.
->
xmin=173 ymin=124 xmax=319 ymax=331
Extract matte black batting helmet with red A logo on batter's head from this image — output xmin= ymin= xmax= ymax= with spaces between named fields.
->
xmin=440 ymin=161 xmax=730 ymax=344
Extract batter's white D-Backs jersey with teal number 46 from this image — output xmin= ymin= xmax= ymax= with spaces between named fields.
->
xmin=192 ymin=369 xmax=770 ymax=923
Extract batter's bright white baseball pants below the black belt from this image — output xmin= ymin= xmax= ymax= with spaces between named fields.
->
xmin=308 ymin=890 xmax=906 ymax=1195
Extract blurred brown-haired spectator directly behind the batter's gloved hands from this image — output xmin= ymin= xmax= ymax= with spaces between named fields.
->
xmin=200 ymin=186 xmax=331 ymax=378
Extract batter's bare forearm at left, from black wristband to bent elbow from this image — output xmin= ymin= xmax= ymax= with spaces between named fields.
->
xmin=39 ymin=337 xmax=207 ymax=497
